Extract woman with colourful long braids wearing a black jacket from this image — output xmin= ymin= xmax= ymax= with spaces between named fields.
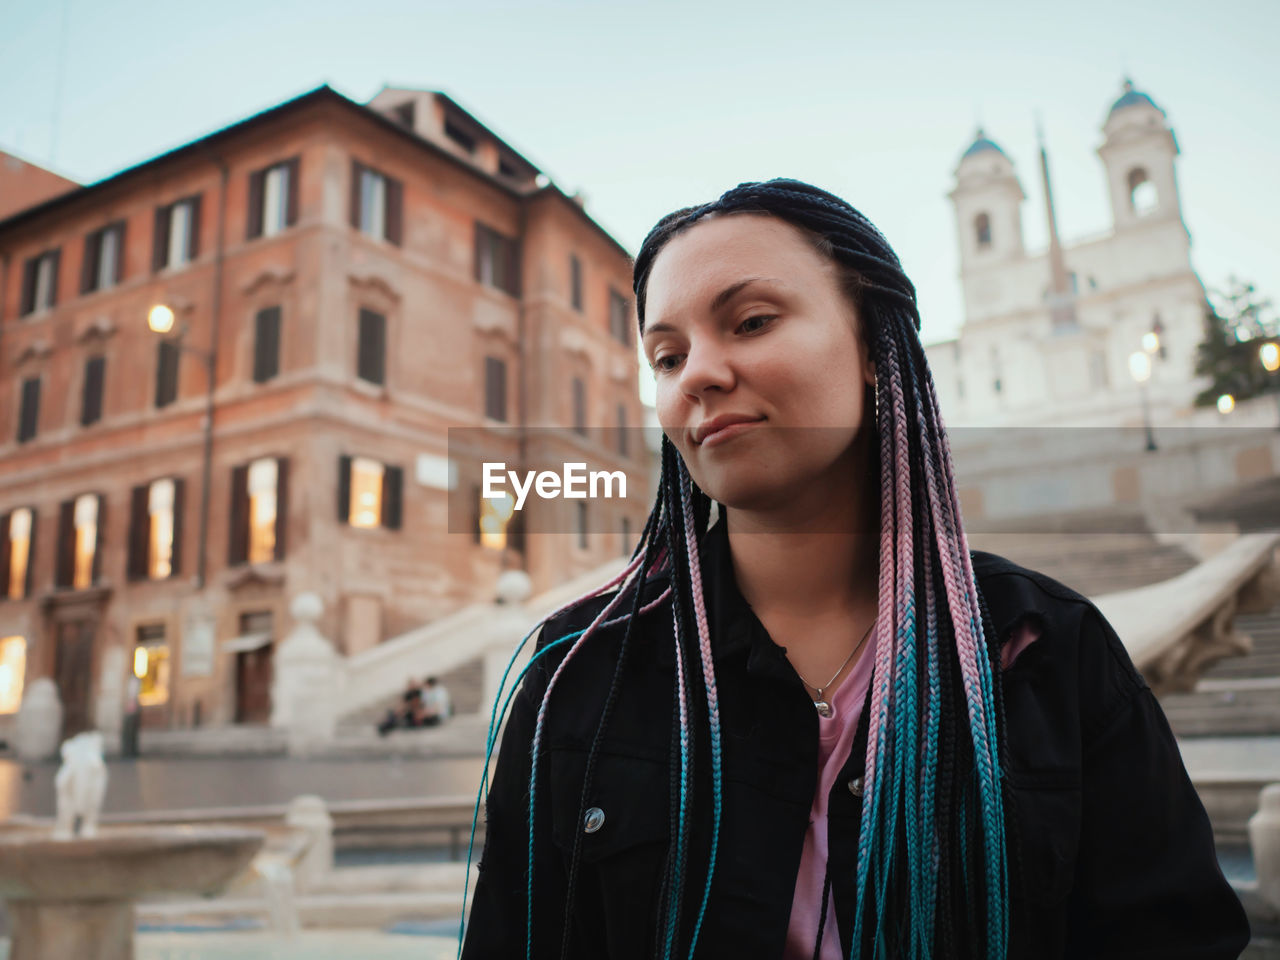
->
xmin=462 ymin=180 xmax=1249 ymax=960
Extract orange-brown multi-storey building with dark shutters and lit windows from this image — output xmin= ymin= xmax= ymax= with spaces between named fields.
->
xmin=0 ymin=87 xmax=652 ymax=733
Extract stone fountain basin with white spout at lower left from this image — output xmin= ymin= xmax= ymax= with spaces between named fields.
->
xmin=0 ymin=732 xmax=265 ymax=960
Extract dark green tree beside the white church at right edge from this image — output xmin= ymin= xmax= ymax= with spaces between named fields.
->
xmin=1196 ymin=275 xmax=1280 ymax=407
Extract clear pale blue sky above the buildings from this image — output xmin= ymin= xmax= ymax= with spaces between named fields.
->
xmin=0 ymin=0 xmax=1280 ymax=407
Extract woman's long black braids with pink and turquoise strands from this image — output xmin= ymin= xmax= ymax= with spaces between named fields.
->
xmin=460 ymin=179 xmax=1018 ymax=960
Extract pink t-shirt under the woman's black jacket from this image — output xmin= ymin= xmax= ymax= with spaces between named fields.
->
xmin=782 ymin=622 xmax=1039 ymax=960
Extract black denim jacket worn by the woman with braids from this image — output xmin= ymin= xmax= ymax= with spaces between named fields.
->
xmin=462 ymin=522 xmax=1249 ymax=960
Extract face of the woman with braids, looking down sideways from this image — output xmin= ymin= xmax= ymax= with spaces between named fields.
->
xmin=644 ymin=214 xmax=876 ymax=511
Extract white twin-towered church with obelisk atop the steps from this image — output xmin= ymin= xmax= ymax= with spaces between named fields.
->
xmin=927 ymin=81 xmax=1206 ymax=426
